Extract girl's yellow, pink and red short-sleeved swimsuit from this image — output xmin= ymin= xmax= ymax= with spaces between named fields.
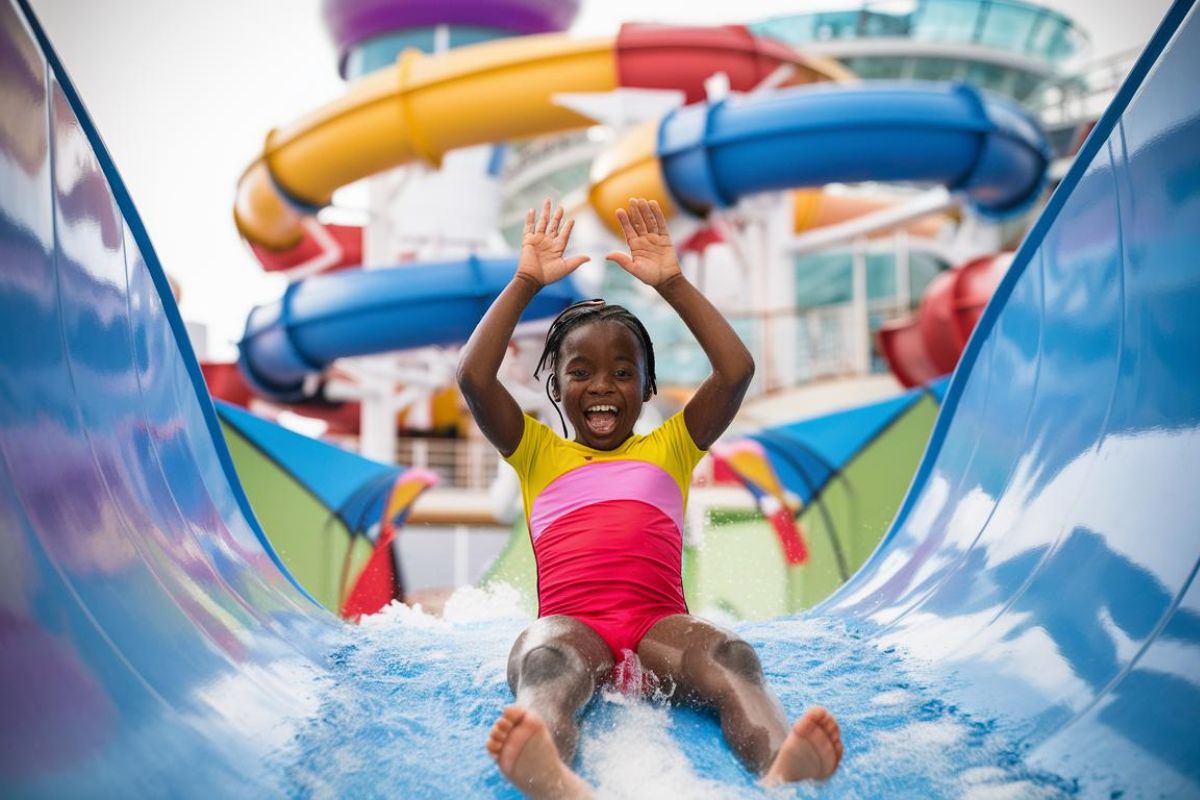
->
xmin=505 ymin=411 xmax=704 ymax=663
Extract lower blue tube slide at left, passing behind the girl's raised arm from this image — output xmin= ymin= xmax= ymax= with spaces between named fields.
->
xmin=238 ymin=255 xmax=580 ymax=402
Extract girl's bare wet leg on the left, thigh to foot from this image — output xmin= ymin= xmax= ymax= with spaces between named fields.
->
xmin=487 ymin=616 xmax=613 ymax=799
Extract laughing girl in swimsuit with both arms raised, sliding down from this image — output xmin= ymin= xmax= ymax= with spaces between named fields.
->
xmin=458 ymin=199 xmax=842 ymax=799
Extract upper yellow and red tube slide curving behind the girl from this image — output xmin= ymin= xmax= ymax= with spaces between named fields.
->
xmin=234 ymin=25 xmax=850 ymax=249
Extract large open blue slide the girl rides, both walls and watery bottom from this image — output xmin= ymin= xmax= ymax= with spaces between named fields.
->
xmin=0 ymin=0 xmax=1200 ymax=798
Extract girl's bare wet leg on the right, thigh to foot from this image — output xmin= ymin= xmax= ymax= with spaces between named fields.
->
xmin=637 ymin=614 xmax=842 ymax=784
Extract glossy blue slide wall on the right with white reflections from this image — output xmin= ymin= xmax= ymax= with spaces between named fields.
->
xmin=818 ymin=0 xmax=1200 ymax=796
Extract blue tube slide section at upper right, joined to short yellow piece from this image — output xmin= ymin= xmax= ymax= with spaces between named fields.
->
xmin=658 ymin=82 xmax=1051 ymax=217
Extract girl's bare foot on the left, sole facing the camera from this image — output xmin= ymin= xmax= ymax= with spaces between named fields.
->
xmin=487 ymin=705 xmax=592 ymax=800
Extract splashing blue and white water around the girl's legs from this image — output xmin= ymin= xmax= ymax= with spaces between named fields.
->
xmin=269 ymin=588 xmax=1076 ymax=800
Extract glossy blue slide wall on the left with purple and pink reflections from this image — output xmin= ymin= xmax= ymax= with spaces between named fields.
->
xmin=0 ymin=0 xmax=340 ymax=796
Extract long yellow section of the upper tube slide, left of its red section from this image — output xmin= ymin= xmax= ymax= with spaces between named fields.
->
xmin=234 ymin=34 xmax=617 ymax=249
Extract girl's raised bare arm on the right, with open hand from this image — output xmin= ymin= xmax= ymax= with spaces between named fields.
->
xmin=608 ymin=199 xmax=754 ymax=450
